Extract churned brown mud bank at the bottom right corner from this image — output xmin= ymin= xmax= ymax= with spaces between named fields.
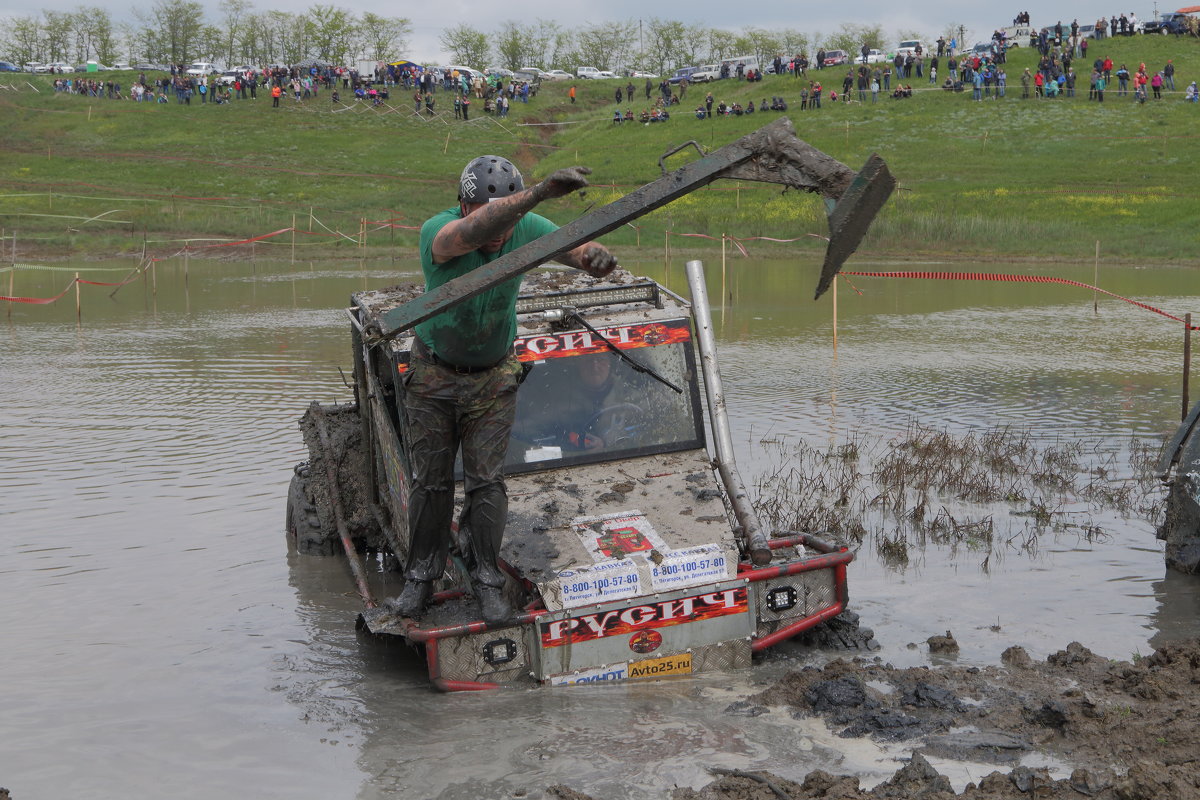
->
xmin=548 ymin=633 xmax=1200 ymax=800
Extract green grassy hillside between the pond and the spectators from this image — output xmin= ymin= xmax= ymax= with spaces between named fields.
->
xmin=0 ymin=36 xmax=1200 ymax=263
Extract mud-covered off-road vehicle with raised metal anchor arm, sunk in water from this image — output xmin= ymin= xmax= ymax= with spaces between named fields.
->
xmin=287 ymin=117 xmax=894 ymax=690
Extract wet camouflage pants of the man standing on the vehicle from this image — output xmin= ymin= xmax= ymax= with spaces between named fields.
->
xmin=404 ymin=353 xmax=522 ymax=588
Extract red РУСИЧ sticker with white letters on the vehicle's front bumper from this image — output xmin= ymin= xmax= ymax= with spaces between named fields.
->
xmin=538 ymin=585 xmax=750 ymax=648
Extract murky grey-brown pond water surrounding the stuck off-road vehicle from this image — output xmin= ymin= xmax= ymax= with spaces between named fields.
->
xmin=0 ymin=258 xmax=1200 ymax=800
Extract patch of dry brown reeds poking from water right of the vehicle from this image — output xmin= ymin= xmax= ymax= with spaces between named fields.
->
xmin=754 ymin=422 xmax=1162 ymax=569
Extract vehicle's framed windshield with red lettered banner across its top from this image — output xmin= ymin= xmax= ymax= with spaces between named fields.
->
xmin=505 ymin=319 xmax=703 ymax=473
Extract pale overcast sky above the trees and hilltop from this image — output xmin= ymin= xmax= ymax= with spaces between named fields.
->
xmin=0 ymin=0 xmax=1171 ymax=66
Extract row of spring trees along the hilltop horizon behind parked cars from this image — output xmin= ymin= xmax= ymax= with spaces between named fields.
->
xmin=0 ymin=0 xmax=962 ymax=74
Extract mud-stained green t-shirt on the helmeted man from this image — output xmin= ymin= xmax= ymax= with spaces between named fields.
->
xmin=416 ymin=206 xmax=558 ymax=367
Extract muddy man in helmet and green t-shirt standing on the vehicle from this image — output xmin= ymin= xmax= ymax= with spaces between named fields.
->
xmin=386 ymin=156 xmax=617 ymax=624
